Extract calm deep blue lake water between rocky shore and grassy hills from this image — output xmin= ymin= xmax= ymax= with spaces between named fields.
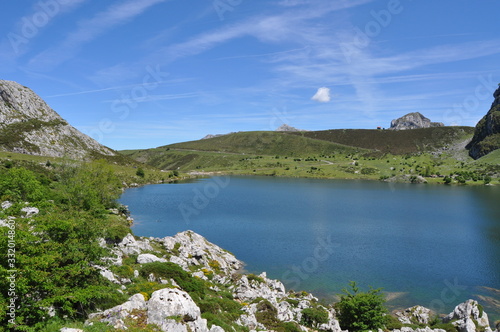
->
xmin=120 ymin=177 xmax=500 ymax=320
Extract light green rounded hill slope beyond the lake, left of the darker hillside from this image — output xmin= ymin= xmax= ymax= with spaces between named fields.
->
xmin=121 ymin=132 xmax=369 ymax=170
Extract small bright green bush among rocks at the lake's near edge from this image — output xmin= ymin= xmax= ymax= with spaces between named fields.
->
xmin=335 ymin=281 xmax=387 ymax=331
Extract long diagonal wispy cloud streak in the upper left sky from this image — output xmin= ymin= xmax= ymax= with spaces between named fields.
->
xmin=28 ymin=0 xmax=166 ymax=70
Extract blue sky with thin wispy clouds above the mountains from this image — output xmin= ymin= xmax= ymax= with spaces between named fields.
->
xmin=0 ymin=0 xmax=500 ymax=149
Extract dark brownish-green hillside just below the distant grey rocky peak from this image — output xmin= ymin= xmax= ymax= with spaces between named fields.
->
xmin=289 ymin=127 xmax=474 ymax=155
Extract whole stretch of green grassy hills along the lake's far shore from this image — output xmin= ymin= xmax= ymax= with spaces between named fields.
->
xmin=118 ymin=127 xmax=500 ymax=184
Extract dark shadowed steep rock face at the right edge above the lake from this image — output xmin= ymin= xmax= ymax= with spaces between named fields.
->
xmin=466 ymin=87 xmax=500 ymax=159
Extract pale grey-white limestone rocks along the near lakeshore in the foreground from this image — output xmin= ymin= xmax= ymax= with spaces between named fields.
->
xmin=52 ymin=227 xmax=500 ymax=332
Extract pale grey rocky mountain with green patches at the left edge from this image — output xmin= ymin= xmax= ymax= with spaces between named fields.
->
xmin=0 ymin=80 xmax=118 ymax=159
